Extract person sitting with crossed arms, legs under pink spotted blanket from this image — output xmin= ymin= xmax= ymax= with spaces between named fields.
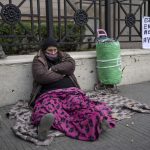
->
xmin=29 ymin=38 xmax=115 ymax=141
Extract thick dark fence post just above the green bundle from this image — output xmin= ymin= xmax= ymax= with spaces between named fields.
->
xmin=105 ymin=0 xmax=111 ymax=36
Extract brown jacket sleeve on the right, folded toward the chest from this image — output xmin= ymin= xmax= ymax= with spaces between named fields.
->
xmin=51 ymin=52 xmax=75 ymax=75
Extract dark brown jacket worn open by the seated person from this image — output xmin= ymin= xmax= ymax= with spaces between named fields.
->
xmin=29 ymin=50 xmax=80 ymax=106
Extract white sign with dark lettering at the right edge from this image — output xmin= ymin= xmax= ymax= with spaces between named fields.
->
xmin=142 ymin=16 xmax=150 ymax=49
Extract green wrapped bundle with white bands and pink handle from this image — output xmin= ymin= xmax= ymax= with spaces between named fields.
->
xmin=96 ymin=29 xmax=122 ymax=85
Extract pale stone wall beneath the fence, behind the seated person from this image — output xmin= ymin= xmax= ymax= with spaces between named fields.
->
xmin=0 ymin=49 xmax=150 ymax=106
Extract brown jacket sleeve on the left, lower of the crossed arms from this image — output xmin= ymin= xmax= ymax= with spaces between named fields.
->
xmin=32 ymin=57 xmax=64 ymax=84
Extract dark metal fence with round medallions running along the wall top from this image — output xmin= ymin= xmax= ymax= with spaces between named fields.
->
xmin=0 ymin=0 xmax=150 ymax=54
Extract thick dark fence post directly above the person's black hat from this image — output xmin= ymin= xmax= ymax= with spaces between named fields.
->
xmin=46 ymin=0 xmax=53 ymax=38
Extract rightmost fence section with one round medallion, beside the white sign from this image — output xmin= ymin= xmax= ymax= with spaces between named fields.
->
xmin=105 ymin=0 xmax=150 ymax=43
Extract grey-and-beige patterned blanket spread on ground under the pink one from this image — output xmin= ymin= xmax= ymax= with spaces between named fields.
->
xmin=8 ymin=91 xmax=150 ymax=145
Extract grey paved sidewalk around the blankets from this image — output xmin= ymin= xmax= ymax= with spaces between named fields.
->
xmin=0 ymin=82 xmax=150 ymax=150
